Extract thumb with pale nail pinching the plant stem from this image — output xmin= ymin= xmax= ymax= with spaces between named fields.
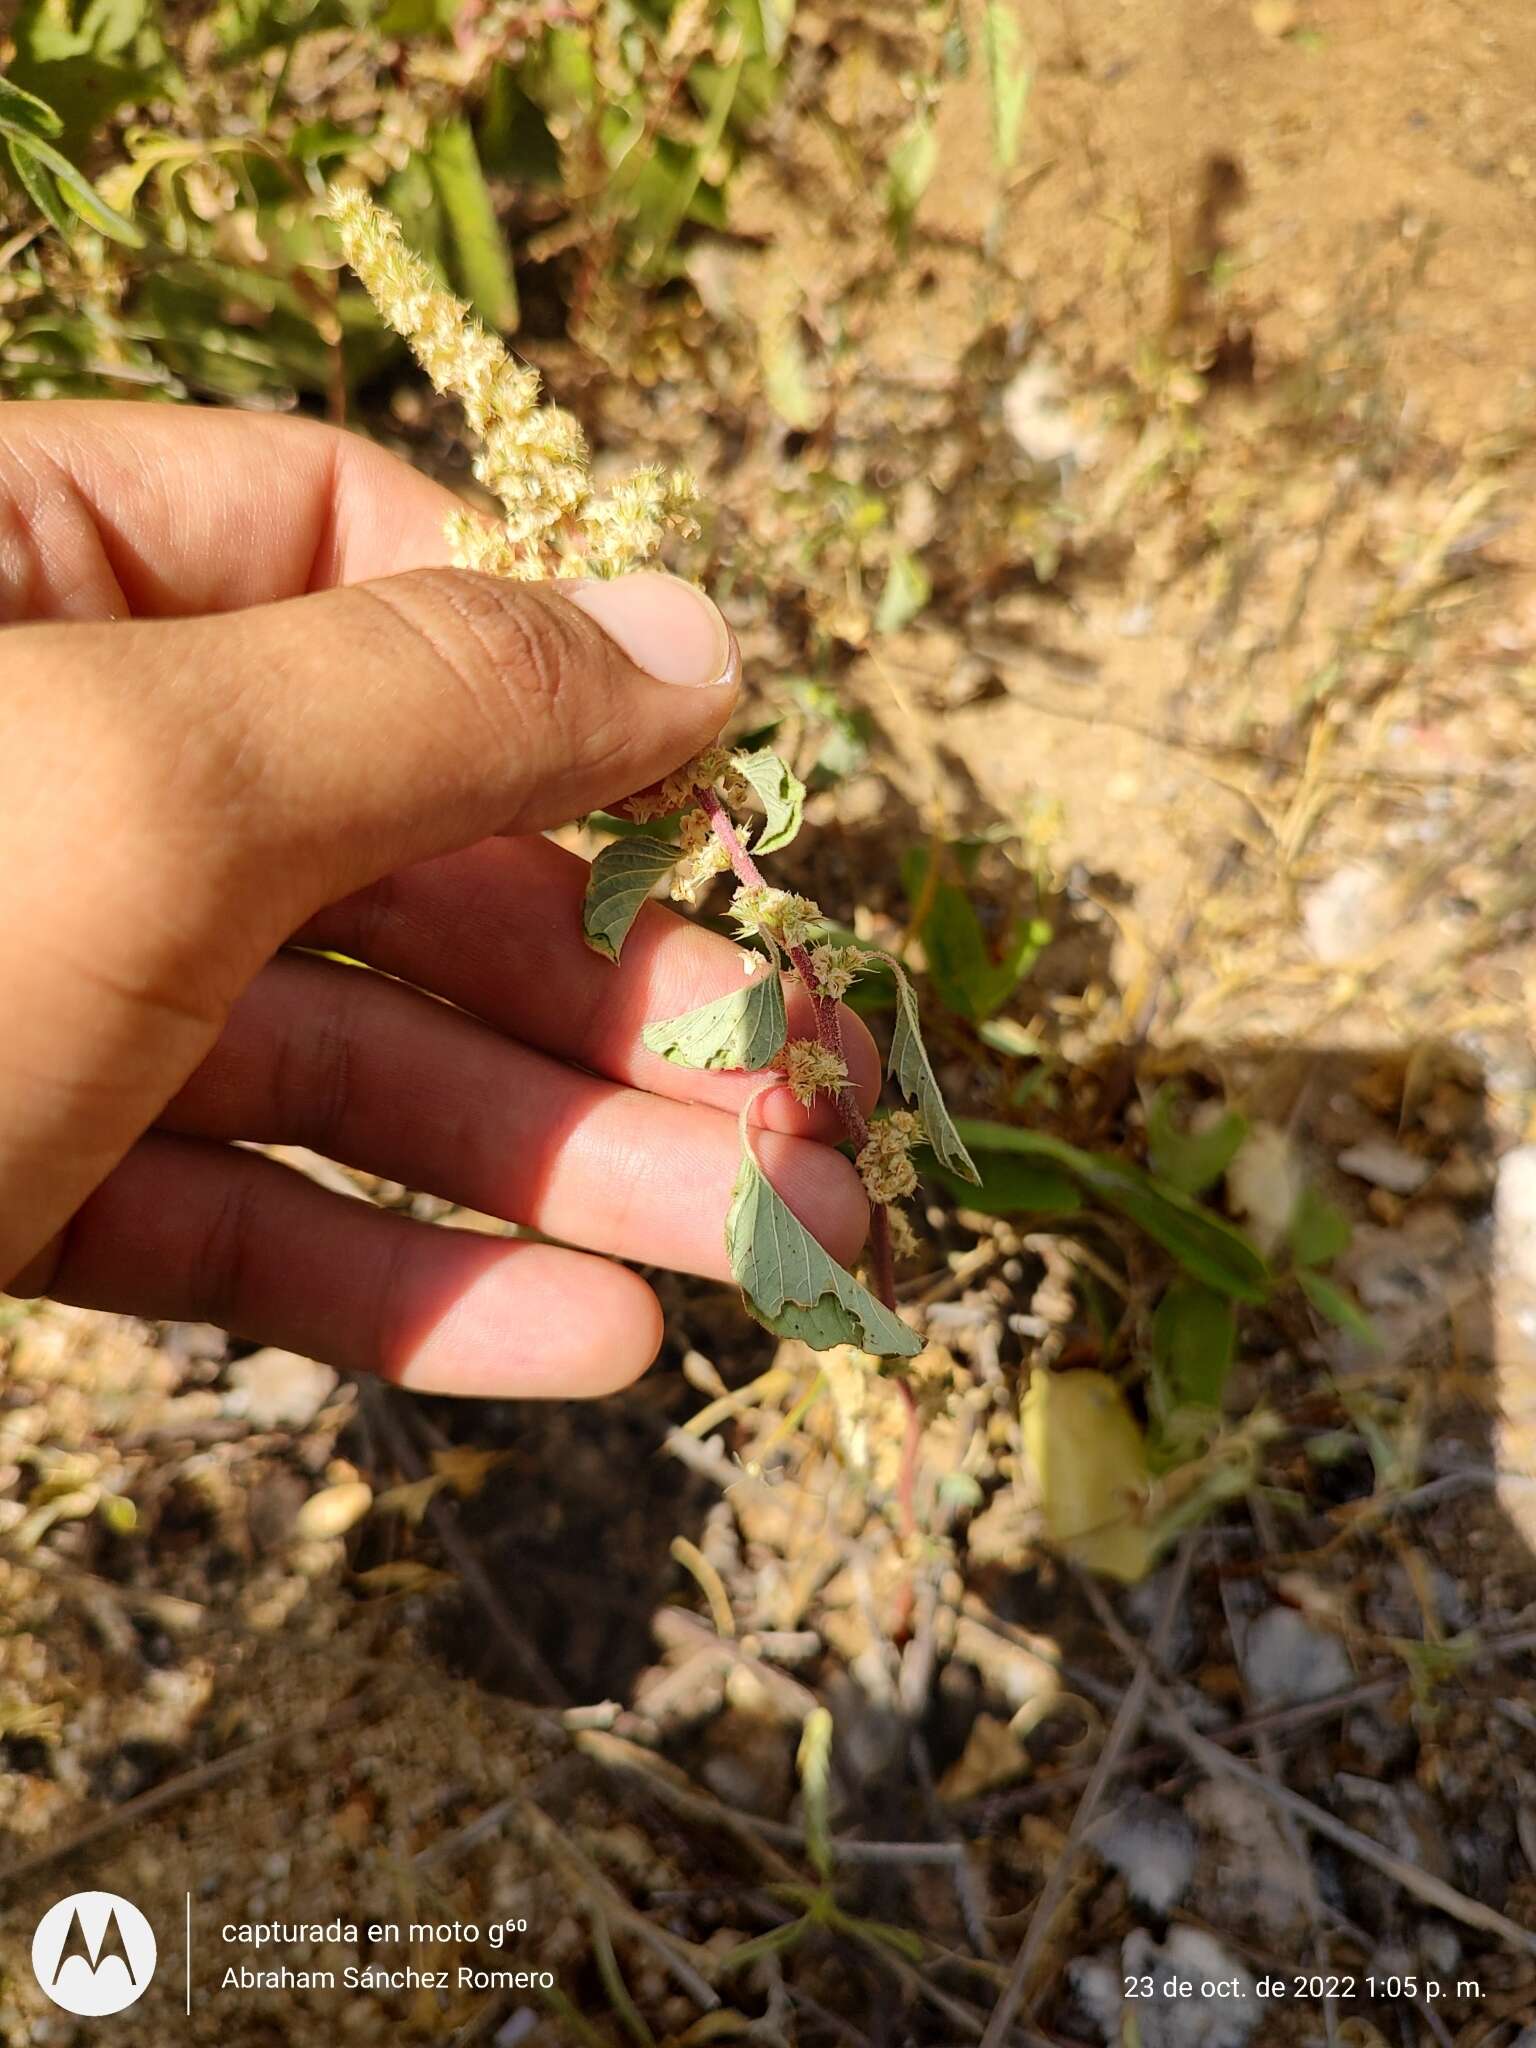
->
xmin=154 ymin=569 xmax=739 ymax=915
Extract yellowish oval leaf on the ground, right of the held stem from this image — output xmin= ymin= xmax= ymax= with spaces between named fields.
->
xmin=1022 ymin=1370 xmax=1157 ymax=1581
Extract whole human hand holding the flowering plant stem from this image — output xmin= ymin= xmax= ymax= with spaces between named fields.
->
xmin=0 ymin=401 xmax=879 ymax=1395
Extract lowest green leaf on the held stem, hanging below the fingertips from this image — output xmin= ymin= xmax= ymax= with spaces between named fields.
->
xmin=725 ymin=1110 xmax=922 ymax=1358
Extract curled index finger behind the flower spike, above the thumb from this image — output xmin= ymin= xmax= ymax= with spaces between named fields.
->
xmin=0 ymin=399 xmax=459 ymax=625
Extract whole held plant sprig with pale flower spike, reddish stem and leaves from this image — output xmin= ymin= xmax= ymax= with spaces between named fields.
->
xmin=328 ymin=186 xmax=977 ymax=1358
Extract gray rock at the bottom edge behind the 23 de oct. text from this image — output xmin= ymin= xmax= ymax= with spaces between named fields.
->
xmin=1069 ymin=1927 xmax=1266 ymax=2048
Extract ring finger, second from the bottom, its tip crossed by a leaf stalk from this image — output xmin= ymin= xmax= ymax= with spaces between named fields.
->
xmin=160 ymin=954 xmax=868 ymax=1280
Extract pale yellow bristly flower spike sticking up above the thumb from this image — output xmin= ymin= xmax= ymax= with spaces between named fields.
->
xmin=326 ymin=184 xmax=696 ymax=580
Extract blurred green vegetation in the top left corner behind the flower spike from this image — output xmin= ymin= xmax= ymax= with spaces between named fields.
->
xmin=0 ymin=0 xmax=876 ymax=412
